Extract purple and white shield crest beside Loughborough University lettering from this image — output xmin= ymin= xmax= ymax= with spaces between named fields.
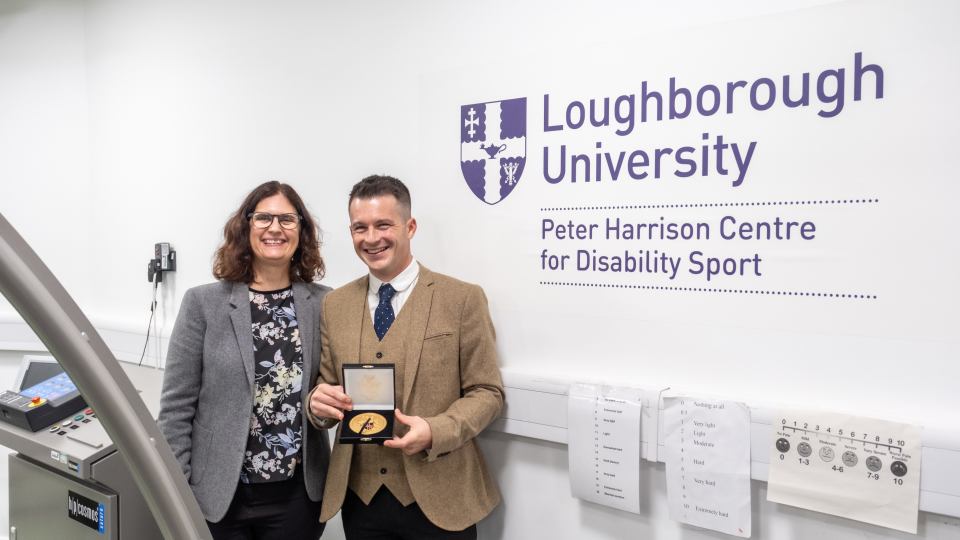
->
xmin=460 ymin=98 xmax=527 ymax=204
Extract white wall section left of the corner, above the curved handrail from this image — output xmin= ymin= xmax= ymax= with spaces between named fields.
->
xmin=0 ymin=0 xmax=92 ymax=312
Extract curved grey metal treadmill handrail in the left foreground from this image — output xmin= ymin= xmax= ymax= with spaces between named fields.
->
xmin=0 ymin=214 xmax=212 ymax=540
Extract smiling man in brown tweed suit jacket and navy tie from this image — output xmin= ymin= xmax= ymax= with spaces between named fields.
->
xmin=308 ymin=176 xmax=503 ymax=540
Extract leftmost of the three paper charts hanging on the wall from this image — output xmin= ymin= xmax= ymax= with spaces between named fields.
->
xmin=567 ymin=383 xmax=643 ymax=513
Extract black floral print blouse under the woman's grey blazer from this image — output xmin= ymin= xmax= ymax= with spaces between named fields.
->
xmin=240 ymin=287 xmax=303 ymax=484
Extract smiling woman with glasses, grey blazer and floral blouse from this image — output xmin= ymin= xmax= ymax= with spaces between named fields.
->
xmin=159 ymin=182 xmax=329 ymax=540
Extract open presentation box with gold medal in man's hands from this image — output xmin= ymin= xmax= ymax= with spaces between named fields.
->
xmin=338 ymin=364 xmax=396 ymax=444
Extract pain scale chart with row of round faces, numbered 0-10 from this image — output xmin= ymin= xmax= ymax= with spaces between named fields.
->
xmin=767 ymin=412 xmax=921 ymax=533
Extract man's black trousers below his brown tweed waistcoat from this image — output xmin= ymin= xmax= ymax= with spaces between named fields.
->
xmin=341 ymin=486 xmax=477 ymax=540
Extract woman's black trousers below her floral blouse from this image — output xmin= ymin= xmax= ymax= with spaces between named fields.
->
xmin=207 ymin=469 xmax=325 ymax=540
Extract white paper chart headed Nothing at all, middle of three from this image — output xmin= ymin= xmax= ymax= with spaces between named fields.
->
xmin=663 ymin=397 xmax=751 ymax=538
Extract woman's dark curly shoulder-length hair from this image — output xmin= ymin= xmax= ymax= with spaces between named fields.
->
xmin=213 ymin=181 xmax=326 ymax=283
